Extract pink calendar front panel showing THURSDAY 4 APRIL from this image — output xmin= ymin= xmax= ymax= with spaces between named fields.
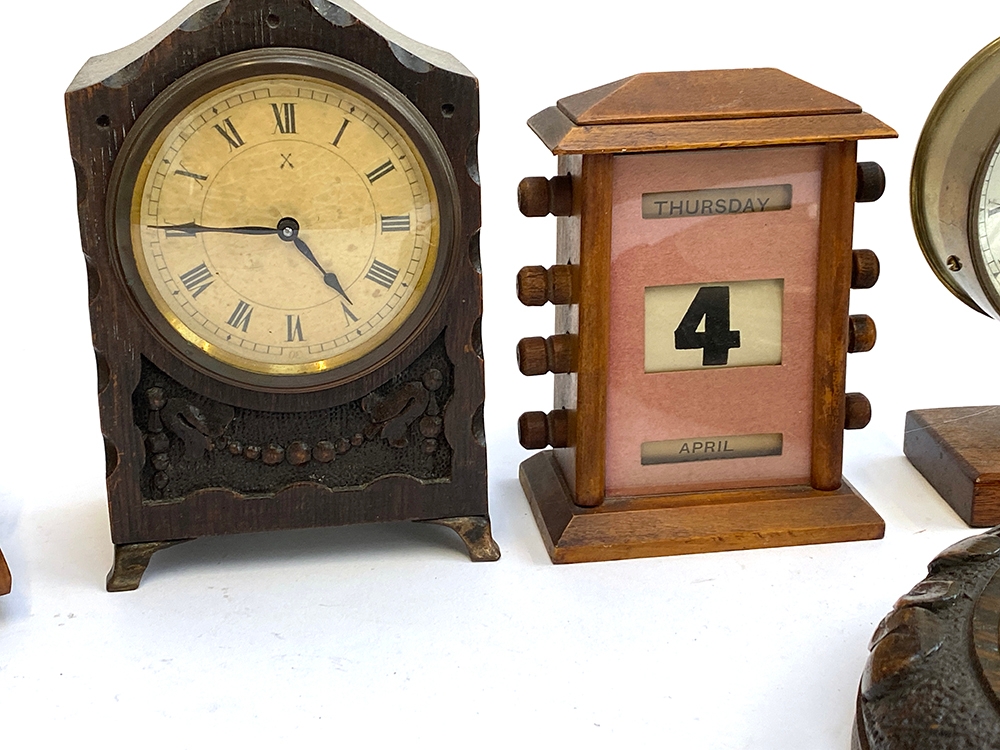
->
xmin=606 ymin=146 xmax=823 ymax=497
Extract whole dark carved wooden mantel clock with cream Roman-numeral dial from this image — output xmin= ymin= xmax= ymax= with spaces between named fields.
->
xmin=66 ymin=0 xmax=499 ymax=590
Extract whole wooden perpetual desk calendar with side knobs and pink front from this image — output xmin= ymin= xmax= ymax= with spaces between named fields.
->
xmin=518 ymin=69 xmax=896 ymax=562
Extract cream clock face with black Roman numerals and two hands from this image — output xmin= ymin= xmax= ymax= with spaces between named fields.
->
xmin=130 ymin=75 xmax=440 ymax=375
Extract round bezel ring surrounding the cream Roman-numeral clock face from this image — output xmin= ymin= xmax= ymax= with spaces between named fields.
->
xmin=108 ymin=48 xmax=461 ymax=393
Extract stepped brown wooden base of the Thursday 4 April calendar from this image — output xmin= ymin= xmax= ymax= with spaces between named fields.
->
xmin=520 ymin=451 xmax=885 ymax=563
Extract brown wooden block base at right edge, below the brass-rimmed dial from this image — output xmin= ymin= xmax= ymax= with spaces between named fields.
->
xmin=903 ymin=406 xmax=1000 ymax=526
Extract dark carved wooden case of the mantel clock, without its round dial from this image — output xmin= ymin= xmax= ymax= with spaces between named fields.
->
xmin=66 ymin=0 xmax=499 ymax=590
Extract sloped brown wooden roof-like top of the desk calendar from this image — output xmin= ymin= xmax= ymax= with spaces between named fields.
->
xmin=528 ymin=68 xmax=897 ymax=154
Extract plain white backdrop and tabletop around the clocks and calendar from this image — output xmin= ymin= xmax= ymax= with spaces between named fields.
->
xmin=0 ymin=0 xmax=1000 ymax=750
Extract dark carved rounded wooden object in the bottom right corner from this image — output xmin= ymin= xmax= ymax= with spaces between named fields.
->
xmin=851 ymin=528 xmax=1000 ymax=750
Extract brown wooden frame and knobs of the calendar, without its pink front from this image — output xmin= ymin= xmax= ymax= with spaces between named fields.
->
xmin=518 ymin=68 xmax=896 ymax=563
